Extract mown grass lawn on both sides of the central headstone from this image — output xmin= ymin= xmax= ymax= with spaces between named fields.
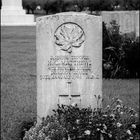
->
xmin=1 ymin=27 xmax=139 ymax=140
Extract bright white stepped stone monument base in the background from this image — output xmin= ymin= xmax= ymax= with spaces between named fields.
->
xmin=1 ymin=0 xmax=35 ymax=26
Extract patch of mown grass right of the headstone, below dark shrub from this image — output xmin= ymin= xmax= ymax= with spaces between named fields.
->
xmin=103 ymin=79 xmax=139 ymax=112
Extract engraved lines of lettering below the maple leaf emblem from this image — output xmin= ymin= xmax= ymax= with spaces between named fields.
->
xmin=40 ymin=56 xmax=98 ymax=80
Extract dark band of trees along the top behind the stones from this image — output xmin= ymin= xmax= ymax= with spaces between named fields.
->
xmin=20 ymin=0 xmax=140 ymax=14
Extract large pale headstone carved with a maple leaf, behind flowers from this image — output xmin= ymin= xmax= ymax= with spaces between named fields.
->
xmin=37 ymin=12 xmax=102 ymax=117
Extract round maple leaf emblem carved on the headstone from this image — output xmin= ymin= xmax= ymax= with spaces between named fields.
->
xmin=54 ymin=23 xmax=85 ymax=53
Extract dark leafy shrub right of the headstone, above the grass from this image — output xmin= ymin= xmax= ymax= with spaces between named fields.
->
xmin=103 ymin=21 xmax=140 ymax=78
